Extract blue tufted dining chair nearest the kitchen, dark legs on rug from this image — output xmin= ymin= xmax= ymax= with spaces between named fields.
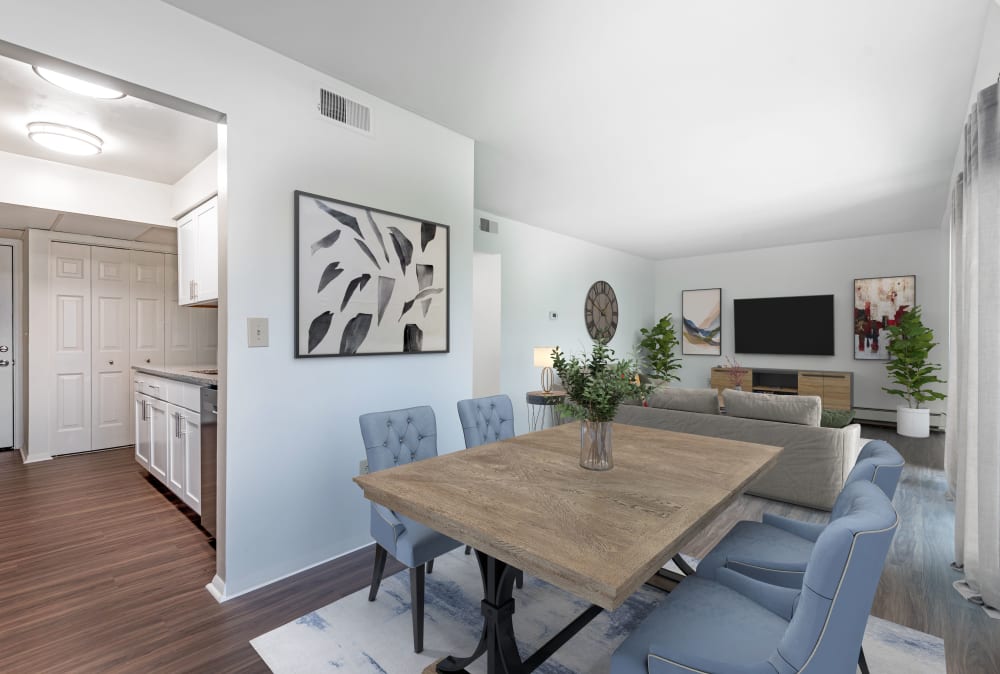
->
xmin=358 ymin=406 xmax=459 ymax=653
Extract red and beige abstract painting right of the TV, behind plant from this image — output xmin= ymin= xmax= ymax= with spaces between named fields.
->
xmin=853 ymin=275 xmax=917 ymax=360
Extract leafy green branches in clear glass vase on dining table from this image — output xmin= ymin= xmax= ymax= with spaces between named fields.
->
xmin=552 ymin=340 xmax=649 ymax=470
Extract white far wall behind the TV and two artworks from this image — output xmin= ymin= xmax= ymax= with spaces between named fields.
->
xmin=655 ymin=229 xmax=948 ymax=410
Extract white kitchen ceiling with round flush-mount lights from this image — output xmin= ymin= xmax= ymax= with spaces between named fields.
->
xmin=0 ymin=51 xmax=218 ymax=185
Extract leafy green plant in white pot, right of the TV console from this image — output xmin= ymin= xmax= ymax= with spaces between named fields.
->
xmin=882 ymin=307 xmax=945 ymax=438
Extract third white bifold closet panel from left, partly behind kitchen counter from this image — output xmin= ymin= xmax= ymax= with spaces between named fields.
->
xmin=129 ymin=251 xmax=164 ymax=367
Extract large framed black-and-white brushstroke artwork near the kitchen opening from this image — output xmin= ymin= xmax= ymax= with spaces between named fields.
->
xmin=295 ymin=191 xmax=450 ymax=358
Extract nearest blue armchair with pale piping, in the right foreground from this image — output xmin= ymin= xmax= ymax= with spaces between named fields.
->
xmin=611 ymin=481 xmax=898 ymax=674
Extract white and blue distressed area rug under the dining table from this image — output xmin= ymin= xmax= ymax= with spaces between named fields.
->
xmin=250 ymin=549 xmax=945 ymax=674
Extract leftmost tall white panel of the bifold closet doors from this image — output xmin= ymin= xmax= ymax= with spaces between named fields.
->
xmin=49 ymin=243 xmax=91 ymax=454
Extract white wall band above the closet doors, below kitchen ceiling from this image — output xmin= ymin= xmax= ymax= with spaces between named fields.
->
xmin=0 ymin=148 xmax=174 ymax=226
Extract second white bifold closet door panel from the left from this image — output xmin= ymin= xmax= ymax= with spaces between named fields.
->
xmin=90 ymin=246 xmax=132 ymax=449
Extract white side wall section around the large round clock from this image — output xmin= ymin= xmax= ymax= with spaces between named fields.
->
xmin=475 ymin=211 xmax=653 ymax=433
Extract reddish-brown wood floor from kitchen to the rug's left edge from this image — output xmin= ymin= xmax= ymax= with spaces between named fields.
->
xmin=0 ymin=449 xmax=398 ymax=673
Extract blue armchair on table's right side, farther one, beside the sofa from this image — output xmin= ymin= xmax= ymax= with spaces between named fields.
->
xmin=698 ymin=440 xmax=904 ymax=588
